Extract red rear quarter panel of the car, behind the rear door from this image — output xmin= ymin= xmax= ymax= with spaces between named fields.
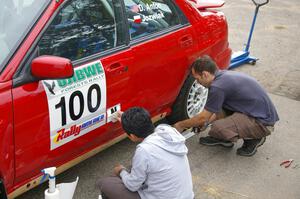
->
xmin=176 ymin=0 xmax=231 ymax=69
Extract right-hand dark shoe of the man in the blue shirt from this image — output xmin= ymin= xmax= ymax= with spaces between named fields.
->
xmin=236 ymin=137 xmax=266 ymax=156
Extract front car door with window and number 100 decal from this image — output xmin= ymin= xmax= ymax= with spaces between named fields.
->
xmin=12 ymin=0 xmax=133 ymax=183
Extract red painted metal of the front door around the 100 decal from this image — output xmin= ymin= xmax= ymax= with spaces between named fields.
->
xmin=12 ymin=50 xmax=133 ymax=186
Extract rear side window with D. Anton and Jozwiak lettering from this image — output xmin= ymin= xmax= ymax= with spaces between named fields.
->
xmin=124 ymin=0 xmax=180 ymax=39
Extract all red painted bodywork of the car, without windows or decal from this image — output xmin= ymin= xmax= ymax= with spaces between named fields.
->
xmin=0 ymin=0 xmax=231 ymax=197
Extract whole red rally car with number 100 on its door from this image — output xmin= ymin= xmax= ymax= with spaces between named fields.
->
xmin=0 ymin=0 xmax=231 ymax=199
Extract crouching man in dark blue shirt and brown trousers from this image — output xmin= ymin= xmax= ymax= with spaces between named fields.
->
xmin=174 ymin=56 xmax=279 ymax=156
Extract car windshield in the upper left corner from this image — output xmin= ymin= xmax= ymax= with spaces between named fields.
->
xmin=0 ymin=0 xmax=49 ymax=72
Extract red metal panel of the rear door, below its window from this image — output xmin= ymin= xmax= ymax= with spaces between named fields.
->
xmin=128 ymin=27 xmax=196 ymax=112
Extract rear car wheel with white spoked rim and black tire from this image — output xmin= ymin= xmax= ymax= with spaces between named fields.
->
xmin=167 ymin=75 xmax=208 ymax=124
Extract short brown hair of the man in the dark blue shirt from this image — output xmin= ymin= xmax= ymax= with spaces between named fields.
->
xmin=192 ymin=55 xmax=217 ymax=74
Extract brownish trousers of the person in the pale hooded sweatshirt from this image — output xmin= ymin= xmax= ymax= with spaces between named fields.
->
xmin=97 ymin=176 xmax=141 ymax=199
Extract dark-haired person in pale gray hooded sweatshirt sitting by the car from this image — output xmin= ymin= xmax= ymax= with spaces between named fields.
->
xmin=97 ymin=107 xmax=194 ymax=199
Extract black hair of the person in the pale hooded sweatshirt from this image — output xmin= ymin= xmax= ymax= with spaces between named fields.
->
xmin=121 ymin=107 xmax=155 ymax=138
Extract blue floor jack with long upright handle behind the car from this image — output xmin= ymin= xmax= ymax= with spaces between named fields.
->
xmin=228 ymin=0 xmax=269 ymax=69
